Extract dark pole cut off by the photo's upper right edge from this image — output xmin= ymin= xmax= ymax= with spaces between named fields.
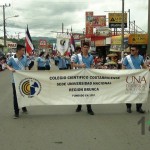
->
xmin=147 ymin=0 xmax=150 ymax=56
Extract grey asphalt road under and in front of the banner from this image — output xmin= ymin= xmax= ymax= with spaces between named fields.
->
xmin=0 ymin=59 xmax=150 ymax=150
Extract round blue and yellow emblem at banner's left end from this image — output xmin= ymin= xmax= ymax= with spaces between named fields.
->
xmin=19 ymin=78 xmax=41 ymax=98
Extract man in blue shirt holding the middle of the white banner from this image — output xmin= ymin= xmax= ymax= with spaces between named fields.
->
xmin=73 ymin=42 xmax=94 ymax=115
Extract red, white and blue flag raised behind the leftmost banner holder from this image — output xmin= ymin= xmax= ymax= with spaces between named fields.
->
xmin=25 ymin=26 xmax=34 ymax=54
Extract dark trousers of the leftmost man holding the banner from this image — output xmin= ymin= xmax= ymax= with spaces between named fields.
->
xmin=12 ymin=83 xmax=26 ymax=114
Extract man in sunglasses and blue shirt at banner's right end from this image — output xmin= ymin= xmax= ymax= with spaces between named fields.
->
xmin=122 ymin=45 xmax=147 ymax=113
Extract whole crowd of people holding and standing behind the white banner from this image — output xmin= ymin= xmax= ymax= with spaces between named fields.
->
xmin=0 ymin=42 xmax=150 ymax=119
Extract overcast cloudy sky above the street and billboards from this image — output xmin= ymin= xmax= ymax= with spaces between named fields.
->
xmin=0 ymin=0 xmax=148 ymax=38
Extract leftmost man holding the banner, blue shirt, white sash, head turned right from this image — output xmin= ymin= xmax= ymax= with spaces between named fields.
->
xmin=6 ymin=44 xmax=28 ymax=119
